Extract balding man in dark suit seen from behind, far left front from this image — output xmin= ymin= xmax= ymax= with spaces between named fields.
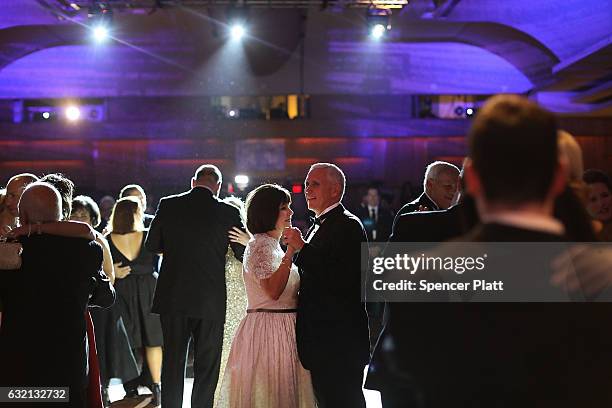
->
xmin=0 ymin=182 xmax=115 ymax=408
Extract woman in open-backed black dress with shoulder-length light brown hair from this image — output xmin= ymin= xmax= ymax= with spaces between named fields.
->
xmin=107 ymin=196 xmax=163 ymax=406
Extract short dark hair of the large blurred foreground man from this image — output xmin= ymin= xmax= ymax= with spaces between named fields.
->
xmin=469 ymin=95 xmax=559 ymax=204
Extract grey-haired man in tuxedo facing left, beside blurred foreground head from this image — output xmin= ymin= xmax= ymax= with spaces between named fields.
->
xmin=395 ymin=161 xmax=459 ymax=221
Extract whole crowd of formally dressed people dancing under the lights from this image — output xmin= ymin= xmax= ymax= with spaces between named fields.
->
xmin=0 ymin=95 xmax=612 ymax=408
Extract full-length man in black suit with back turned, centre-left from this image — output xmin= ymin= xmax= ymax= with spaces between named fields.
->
xmin=146 ymin=165 xmax=244 ymax=408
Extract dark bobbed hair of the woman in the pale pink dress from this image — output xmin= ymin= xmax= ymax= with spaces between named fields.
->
xmin=246 ymin=184 xmax=291 ymax=234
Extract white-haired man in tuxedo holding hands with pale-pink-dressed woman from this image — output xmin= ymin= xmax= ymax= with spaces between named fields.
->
xmin=283 ymin=163 xmax=370 ymax=408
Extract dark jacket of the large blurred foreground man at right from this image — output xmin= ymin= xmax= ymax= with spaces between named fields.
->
xmin=380 ymin=224 xmax=612 ymax=408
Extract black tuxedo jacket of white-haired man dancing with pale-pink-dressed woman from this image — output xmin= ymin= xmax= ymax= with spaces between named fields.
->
xmin=295 ymin=204 xmax=370 ymax=370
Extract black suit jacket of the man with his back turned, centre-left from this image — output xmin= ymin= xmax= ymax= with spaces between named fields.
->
xmin=146 ymin=187 xmax=244 ymax=322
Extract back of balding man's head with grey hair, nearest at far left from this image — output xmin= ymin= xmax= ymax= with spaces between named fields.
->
xmin=19 ymin=181 xmax=62 ymax=224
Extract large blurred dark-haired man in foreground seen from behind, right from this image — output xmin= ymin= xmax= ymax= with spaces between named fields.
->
xmin=378 ymin=95 xmax=612 ymax=408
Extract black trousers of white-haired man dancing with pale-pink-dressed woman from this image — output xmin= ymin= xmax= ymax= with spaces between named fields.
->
xmin=310 ymin=362 xmax=365 ymax=408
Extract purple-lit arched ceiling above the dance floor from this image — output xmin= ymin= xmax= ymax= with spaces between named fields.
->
xmin=0 ymin=0 xmax=612 ymax=111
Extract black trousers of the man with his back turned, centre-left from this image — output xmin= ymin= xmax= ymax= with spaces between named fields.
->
xmin=160 ymin=314 xmax=223 ymax=408
